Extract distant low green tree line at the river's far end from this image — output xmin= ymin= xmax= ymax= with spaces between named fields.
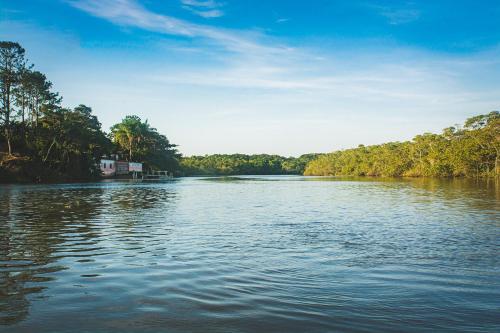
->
xmin=181 ymin=154 xmax=318 ymax=176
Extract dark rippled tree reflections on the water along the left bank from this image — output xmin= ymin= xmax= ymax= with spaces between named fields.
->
xmin=0 ymin=183 xmax=178 ymax=327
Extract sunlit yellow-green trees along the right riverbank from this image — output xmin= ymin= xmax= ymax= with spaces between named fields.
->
xmin=305 ymin=111 xmax=500 ymax=177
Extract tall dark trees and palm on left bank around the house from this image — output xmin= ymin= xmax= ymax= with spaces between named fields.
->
xmin=0 ymin=42 xmax=180 ymax=182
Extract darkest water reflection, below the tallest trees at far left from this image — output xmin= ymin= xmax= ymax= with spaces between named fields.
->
xmin=0 ymin=187 xmax=102 ymax=325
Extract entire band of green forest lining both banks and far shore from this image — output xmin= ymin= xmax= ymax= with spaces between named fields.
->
xmin=0 ymin=41 xmax=500 ymax=182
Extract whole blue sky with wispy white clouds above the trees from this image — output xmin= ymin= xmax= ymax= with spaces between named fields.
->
xmin=0 ymin=0 xmax=500 ymax=156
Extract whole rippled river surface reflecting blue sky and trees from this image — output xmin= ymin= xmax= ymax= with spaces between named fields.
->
xmin=0 ymin=176 xmax=500 ymax=332
